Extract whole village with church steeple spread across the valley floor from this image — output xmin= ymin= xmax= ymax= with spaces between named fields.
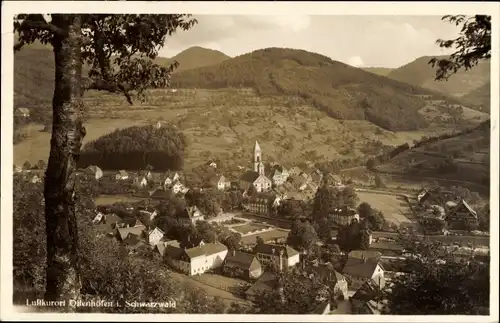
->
xmin=15 ymin=136 xmax=489 ymax=314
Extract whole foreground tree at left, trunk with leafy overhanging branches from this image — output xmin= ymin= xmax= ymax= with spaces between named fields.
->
xmin=14 ymin=14 xmax=196 ymax=300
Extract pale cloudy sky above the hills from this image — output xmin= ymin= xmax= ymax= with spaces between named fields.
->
xmin=160 ymin=15 xmax=459 ymax=67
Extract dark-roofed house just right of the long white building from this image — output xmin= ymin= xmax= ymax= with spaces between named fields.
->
xmin=222 ymin=250 xmax=262 ymax=280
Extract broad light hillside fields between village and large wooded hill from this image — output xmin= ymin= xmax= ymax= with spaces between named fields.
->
xmin=14 ymin=89 xmax=484 ymax=168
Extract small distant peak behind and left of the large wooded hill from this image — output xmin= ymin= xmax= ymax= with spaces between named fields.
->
xmin=169 ymin=46 xmax=231 ymax=73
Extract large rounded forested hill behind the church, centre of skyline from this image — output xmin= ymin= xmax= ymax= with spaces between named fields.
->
xmin=172 ymin=48 xmax=468 ymax=131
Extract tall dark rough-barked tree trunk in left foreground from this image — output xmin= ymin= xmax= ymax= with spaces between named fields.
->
xmin=44 ymin=15 xmax=85 ymax=304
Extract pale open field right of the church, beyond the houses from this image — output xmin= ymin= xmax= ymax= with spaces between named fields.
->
xmin=358 ymin=192 xmax=412 ymax=226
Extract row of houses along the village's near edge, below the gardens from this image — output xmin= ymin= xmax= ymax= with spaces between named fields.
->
xmin=93 ymin=206 xmax=385 ymax=311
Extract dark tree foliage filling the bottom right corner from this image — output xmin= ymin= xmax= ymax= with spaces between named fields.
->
xmin=386 ymin=236 xmax=490 ymax=315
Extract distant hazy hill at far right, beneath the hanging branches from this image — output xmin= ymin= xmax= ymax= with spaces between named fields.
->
xmin=387 ymin=56 xmax=490 ymax=104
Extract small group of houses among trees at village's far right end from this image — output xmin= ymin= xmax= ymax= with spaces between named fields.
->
xmin=417 ymin=189 xmax=479 ymax=230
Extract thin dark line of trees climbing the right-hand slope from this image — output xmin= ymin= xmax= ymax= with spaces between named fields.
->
xmin=366 ymin=119 xmax=491 ymax=169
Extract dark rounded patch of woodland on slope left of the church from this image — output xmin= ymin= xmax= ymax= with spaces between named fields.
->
xmin=78 ymin=125 xmax=186 ymax=171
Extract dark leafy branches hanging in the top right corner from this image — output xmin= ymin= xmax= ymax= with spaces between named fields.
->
xmin=429 ymin=15 xmax=491 ymax=80
